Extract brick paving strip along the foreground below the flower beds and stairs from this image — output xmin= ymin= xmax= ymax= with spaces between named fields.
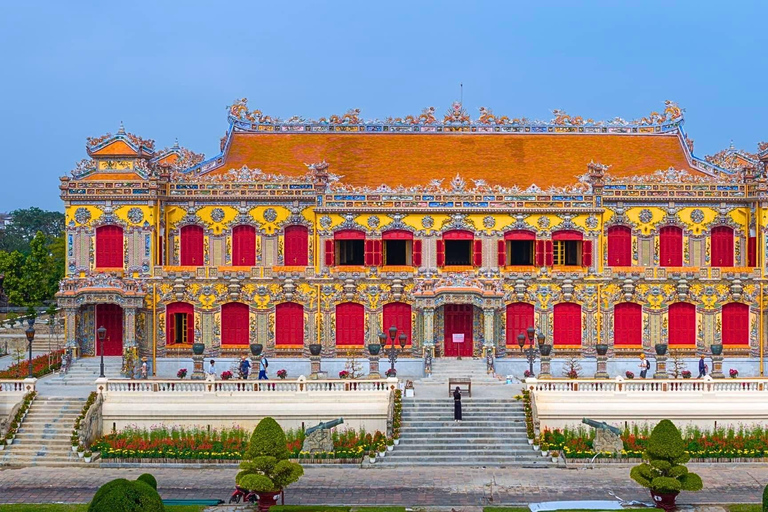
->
xmin=0 ymin=464 xmax=768 ymax=507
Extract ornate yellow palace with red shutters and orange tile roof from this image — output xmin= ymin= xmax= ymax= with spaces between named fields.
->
xmin=58 ymin=100 xmax=768 ymax=364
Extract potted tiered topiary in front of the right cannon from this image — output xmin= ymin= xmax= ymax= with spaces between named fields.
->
xmin=630 ymin=420 xmax=703 ymax=510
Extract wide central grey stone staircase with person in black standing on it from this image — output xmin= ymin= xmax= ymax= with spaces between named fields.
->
xmin=381 ymin=398 xmax=549 ymax=466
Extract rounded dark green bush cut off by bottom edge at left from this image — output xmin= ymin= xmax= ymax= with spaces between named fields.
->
xmin=88 ymin=475 xmax=165 ymax=512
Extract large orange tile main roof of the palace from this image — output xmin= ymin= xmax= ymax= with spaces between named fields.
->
xmin=212 ymin=133 xmax=698 ymax=188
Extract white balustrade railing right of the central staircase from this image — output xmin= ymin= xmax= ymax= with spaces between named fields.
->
xmin=525 ymin=377 xmax=768 ymax=393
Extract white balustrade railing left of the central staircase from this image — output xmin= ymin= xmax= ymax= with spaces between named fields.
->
xmin=96 ymin=377 xmax=397 ymax=394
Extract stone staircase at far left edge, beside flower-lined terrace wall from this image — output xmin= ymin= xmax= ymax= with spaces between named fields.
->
xmin=0 ymin=396 xmax=85 ymax=466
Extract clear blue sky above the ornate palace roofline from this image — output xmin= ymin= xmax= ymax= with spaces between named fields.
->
xmin=0 ymin=0 xmax=768 ymax=211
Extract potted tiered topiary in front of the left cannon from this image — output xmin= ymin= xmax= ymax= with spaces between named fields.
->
xmin=235 ymin=417 xmax=304 ymax=512
